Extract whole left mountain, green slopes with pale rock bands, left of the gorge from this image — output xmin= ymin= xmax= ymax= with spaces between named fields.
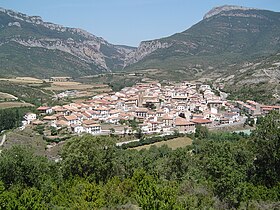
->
xmin=0 ymin=9 xmax=134 ymax=78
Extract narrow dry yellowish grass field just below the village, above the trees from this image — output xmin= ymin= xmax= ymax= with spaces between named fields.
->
xmin=132 ymin=137 xmax=192 ymax=151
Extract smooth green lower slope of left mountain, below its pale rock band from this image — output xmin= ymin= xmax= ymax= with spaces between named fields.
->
xmin=0 ymin=42 xmax=101 ymax=78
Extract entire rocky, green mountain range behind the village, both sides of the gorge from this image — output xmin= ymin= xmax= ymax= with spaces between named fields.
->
xmin=0 ymin=5 xmax=280 ymax=84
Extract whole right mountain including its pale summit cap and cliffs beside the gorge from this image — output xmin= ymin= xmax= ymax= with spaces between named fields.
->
xmin=125 ymin=6 xmax=280 ymax=75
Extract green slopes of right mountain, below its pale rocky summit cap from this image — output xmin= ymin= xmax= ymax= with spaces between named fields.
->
xmin=126 ymin=6 xmax=280 ymax=77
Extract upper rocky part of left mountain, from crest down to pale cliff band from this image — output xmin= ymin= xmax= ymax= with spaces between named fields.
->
xmin=0 ymin=8 xmax=136 ymax=71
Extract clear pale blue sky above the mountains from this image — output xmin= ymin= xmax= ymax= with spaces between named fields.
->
xmin=0 ymin=0 xmax=280 ymax=47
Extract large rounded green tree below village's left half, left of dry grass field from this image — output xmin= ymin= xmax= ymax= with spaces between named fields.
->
xmin=61 ymin=135 xmax=116 ymax=182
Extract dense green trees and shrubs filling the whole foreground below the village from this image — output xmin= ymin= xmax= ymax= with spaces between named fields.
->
xmin=0 ymin=113 xmax=280 ymax=209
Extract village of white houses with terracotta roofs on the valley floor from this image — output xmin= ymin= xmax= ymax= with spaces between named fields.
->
xmin=23 ymin=82 xmax=280 ymax=135
